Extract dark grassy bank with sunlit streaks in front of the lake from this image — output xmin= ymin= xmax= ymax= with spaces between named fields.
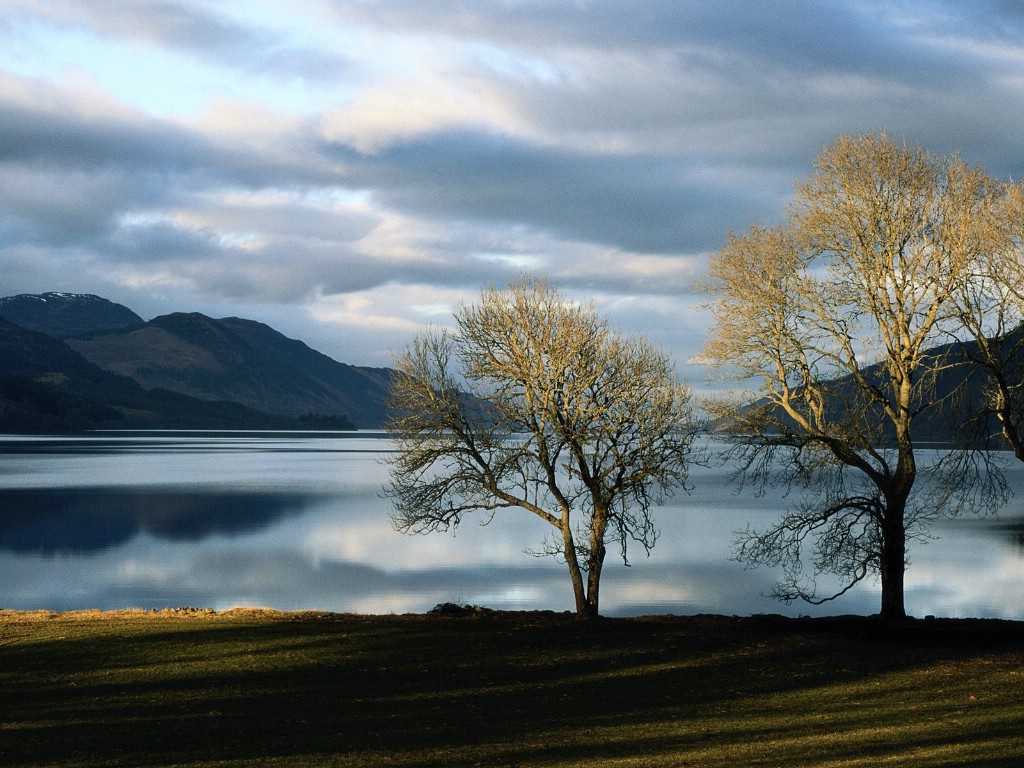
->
xmin=0 ymin=611 xmax=1024 ymax=768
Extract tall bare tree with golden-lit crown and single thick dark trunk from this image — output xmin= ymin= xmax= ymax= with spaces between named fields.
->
xmin=705 ymin=134 xmax=1001 ymax=618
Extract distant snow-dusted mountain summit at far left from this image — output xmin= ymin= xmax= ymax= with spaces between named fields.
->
xmin=0 ymin=293 xmax=143 ymax=339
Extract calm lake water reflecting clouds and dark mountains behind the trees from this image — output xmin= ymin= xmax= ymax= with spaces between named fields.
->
xmin=0 ymin=432 xmax=1024 ymax=618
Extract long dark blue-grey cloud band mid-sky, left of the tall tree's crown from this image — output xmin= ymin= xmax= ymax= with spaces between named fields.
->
xmin=328 ymin=132 xmax=765 ymax=252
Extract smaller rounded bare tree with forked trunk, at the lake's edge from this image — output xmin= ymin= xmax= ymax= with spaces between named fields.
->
xmin=386 ymin=278 xmax=694 ymax=616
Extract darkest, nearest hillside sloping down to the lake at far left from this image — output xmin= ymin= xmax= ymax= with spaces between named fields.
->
xmin=0 ymin=316 xmax=351 ymax=433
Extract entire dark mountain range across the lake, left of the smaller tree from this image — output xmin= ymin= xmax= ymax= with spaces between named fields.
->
xmin=0 ymin=293 xmax=391 ymax=432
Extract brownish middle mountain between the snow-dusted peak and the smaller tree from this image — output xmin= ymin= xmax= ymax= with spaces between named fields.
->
xmin=68 ymin=312 xmax=389 ymax=428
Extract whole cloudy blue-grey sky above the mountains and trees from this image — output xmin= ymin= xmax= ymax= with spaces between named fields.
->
xmin=0 ymin=0 xmax=1024 ymax=376
